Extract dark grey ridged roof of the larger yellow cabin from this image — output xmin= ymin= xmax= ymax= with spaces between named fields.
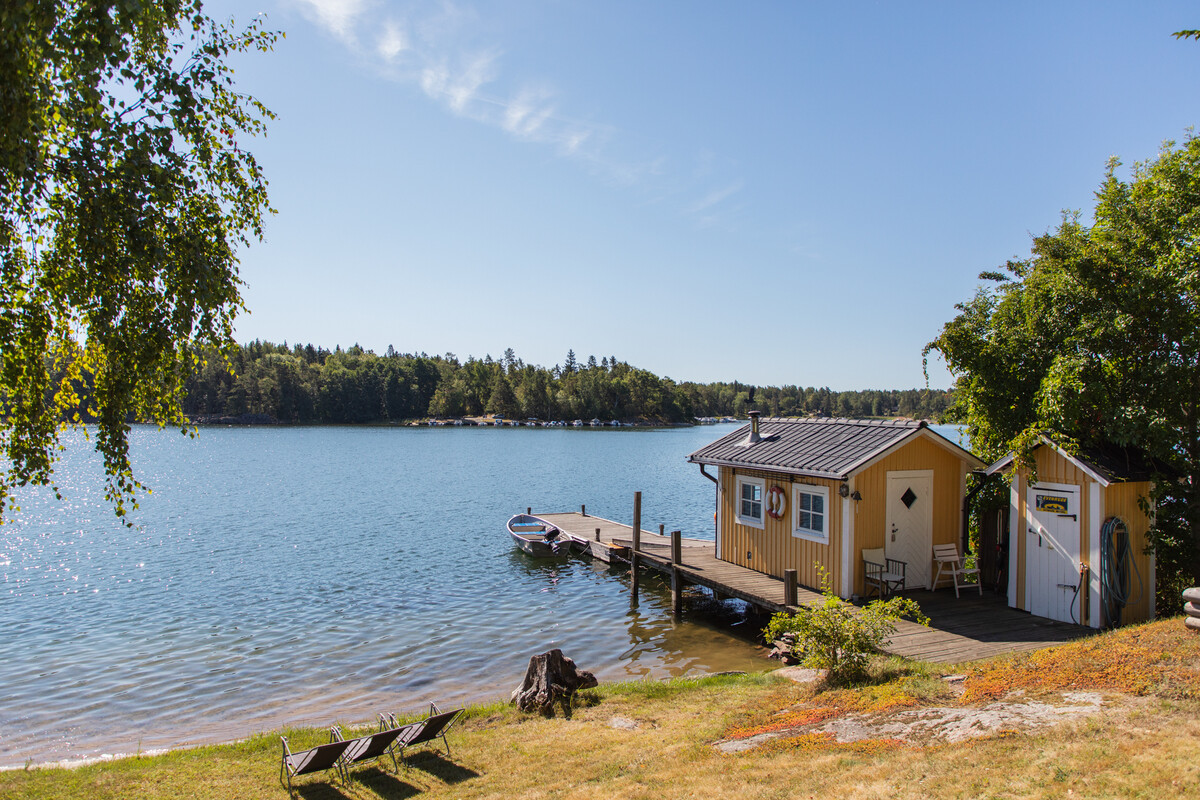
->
xmin=688 ymin=417 xmax=983 ymax=480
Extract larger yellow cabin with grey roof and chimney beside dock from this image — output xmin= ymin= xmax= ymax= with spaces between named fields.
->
xmin=689 ymin=413 xmax=984 ymax=599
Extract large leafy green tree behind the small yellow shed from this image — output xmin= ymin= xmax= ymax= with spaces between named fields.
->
xmin=925 ymin=134 xmax=1200 ymax=594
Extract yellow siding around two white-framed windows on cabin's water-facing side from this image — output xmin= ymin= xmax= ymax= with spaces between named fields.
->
xmin=720 ymin=467 xmax=841 ymax=591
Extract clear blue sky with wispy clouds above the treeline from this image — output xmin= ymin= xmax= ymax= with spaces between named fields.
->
xmin=205 ymin=0 xmax=1200 ymax=391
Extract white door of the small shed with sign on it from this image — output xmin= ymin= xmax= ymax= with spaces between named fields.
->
xmin=1025 ymin=483 xmax=1080 ymax=624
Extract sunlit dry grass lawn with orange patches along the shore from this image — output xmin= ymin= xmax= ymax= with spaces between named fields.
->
xmin=0 ymin=619 xmax=1200 ymax=800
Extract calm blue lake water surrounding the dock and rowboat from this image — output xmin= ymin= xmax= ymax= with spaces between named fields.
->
xmin=0 ymin=426 xmax=770 ymax=766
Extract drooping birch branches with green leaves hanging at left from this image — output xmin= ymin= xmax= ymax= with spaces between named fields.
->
xmin=0 ymin=0 xmax=276 ymax=516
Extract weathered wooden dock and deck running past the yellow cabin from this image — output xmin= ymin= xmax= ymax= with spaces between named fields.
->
xmin=538 ymin=512 xmax=1091 ymax=663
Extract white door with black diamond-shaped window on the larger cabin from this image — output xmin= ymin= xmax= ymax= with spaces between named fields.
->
xmin=883 ymin=469 xmax=934 ymax=589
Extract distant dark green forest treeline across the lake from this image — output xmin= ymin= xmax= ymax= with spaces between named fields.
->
xmin=184 ymin=341 xmax=952 ymax=423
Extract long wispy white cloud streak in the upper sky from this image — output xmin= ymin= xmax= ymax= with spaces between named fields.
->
xmin=286 ymin=0 xmax=743 ymax=225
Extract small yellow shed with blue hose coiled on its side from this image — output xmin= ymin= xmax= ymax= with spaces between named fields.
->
xmin=986 ymin=438 xmax=1154 ymax=627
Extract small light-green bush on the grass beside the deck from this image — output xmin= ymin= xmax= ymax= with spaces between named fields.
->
xmin=763 ymin=569 xmax=929 ymax=684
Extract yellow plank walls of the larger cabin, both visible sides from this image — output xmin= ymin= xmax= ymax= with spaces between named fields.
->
xmin=720 ymin=435 xmax=970 ymax=596
